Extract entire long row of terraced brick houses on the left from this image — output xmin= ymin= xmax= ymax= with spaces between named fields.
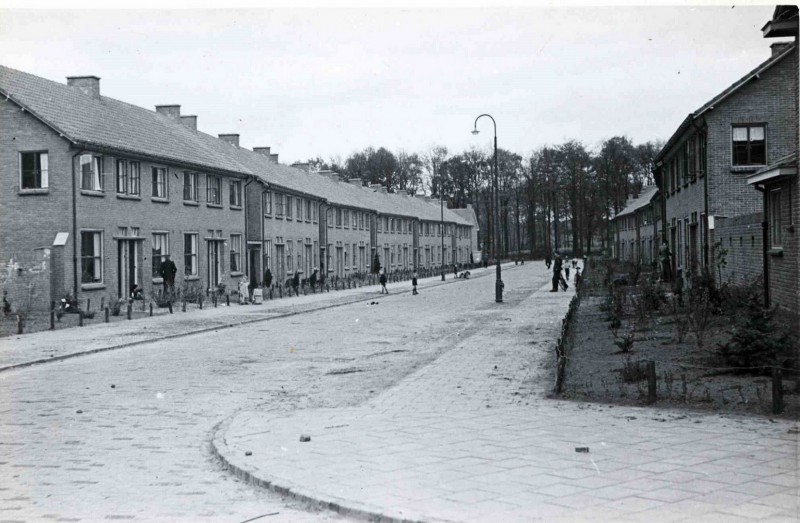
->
xmin=0 ymin=66 xmax=477 ymax=309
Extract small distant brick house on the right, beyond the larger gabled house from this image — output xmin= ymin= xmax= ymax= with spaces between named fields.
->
xmin=612 ymin=185 xmax=661 ymax=263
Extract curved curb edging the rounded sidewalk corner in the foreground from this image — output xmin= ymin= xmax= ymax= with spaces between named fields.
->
xmin=210 ymin=413 xmax=426 ymax=523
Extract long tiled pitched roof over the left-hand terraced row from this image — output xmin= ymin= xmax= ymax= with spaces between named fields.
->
xmin=0 ymin=65 xmax=467 ymax=224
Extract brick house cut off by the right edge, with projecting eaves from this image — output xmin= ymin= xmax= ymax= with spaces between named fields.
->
xmin=747 ymin=6 xmax=800 ymax=332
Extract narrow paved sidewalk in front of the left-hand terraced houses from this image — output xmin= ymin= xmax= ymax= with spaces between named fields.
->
xmin=0 ymin=263 xmax=506 ymax=372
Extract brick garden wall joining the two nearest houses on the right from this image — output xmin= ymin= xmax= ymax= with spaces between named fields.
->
xmin=714 ymin=213 xmax=764 ymax=285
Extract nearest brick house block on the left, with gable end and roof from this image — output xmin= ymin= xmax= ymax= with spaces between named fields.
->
xmin=0 ymin=67 xmax=248 ymax=307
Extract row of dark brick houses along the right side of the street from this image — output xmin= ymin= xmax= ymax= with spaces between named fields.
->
xmin=614 ymin=6 xmax=800 ymax=330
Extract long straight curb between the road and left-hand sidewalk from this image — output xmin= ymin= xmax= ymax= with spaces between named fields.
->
xmin=0 ymin=269 xmax=520 ymax=373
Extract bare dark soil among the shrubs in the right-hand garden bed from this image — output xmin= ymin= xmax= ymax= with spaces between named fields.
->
xmin=564 ymin=262 xmax=800 ymax=420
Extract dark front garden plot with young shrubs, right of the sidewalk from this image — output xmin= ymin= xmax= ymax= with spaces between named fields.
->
xmin=563 ymin=262 xmax=800 ymax=419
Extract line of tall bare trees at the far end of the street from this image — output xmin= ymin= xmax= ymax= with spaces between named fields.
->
xmin=308 ymin=136 xmax=663 ymax=256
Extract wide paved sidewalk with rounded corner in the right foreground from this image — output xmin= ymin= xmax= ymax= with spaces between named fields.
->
xmin=213 ymin=280 xmax=800 ymax=522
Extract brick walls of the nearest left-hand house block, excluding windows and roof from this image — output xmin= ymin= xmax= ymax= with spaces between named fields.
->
xmin=0 ymin=97 xmax=245 ymax=307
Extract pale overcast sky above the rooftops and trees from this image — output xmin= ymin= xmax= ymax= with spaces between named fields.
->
xmin=0 ymin=5 xmax=774 ymax=163
